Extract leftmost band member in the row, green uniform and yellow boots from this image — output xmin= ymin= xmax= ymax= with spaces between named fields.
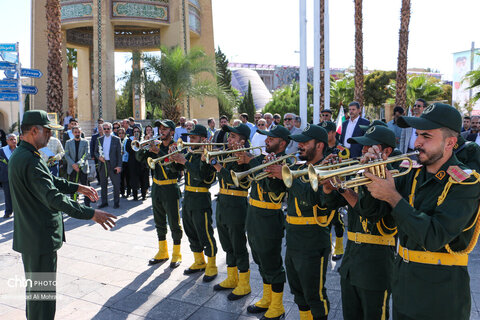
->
xmin=135 ymin=119 xmax=183 ymax=268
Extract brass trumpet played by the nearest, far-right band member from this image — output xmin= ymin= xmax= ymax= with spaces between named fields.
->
xmin=308 ymin=151 xmax=418 ymax=191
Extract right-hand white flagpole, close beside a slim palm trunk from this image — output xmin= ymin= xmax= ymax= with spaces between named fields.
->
xmin=313 ymin=0 xmax=321 ymax=123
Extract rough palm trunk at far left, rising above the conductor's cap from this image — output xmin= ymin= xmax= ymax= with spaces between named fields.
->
xmin=46 ymin=0 xmax=63 ymax=119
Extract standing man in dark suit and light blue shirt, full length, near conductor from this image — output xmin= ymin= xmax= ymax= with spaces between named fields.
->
xmin=95 ymin=122 xmax=122 ymax=209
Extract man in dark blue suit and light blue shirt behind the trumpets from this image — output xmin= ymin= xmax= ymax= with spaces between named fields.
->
xmin=340 ymin=101 xmax=370 ymax=158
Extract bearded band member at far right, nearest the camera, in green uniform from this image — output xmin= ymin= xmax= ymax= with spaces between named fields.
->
xmin=365 ymin=103 xmax=480 ymax=320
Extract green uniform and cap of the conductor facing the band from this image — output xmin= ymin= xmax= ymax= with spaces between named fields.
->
xmin=8 ymin=110 xmax=94 ymax=320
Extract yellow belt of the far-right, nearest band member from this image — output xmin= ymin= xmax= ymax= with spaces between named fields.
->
xmin=398 ymin=244 xmax=468 ymax=266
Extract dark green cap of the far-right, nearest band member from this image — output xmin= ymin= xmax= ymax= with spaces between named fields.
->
xmin=397 ymin=103 xmax=462 ymax=132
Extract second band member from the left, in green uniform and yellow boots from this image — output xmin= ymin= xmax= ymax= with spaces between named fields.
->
xmin=170 ymin=124 xmax=218 ymax=282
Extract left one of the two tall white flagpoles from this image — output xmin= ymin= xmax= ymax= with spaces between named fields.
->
xmin=300 ymin=0 xmax=308 ymax=129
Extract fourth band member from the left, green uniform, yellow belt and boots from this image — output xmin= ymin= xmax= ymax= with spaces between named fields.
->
xmin=239 ymin=125 xmax=290 ymax=320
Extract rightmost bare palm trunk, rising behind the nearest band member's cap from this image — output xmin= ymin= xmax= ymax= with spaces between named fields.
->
xmin=395 ymin=0 xmax=410 ymax=108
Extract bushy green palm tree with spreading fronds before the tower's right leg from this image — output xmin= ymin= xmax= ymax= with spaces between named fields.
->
xmin=144 ymin=46 xmax=233 ymax=122
